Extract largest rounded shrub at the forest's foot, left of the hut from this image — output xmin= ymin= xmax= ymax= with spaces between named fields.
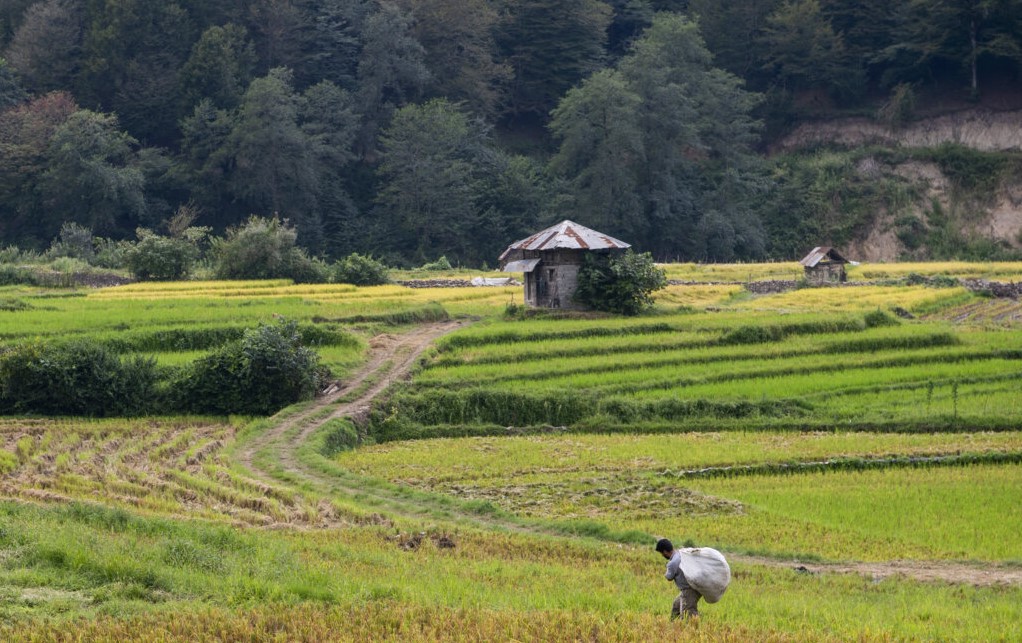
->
xmin=213 ymin=217 xmax=328 ymax=283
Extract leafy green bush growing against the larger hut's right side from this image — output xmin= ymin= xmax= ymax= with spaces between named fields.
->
xmin=575 ymin=250 xmax=667 ymax=315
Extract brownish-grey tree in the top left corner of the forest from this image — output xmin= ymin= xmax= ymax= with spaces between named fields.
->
xmin=6 ymin=0 xmax=83 ymax=92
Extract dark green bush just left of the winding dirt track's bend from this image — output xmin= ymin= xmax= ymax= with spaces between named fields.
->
xmin=172 ymin=320 xmax=324 ymax=415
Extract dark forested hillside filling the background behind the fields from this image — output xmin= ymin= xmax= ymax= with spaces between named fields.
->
xmin=0 ymin=0 xmax=1022 ymax=266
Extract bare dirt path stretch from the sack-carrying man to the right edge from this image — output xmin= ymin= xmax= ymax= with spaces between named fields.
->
xmin=728 ymin=554 xmax=1022 ymax=587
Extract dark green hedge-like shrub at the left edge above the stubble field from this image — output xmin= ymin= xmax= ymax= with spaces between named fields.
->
xmin=0 ymin=340 xmax=157 ymax=416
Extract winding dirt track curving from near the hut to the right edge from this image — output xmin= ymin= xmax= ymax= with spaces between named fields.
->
xmin=235 ymin=320 xmax=1022 ymax=586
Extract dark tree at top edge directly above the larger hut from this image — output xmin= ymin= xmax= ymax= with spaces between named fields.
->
xmin=500 ymin=0 xmax=611 ymax=118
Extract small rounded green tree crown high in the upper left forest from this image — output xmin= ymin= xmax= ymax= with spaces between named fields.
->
xmin=179 ymin=25 xmax=257 ymax=112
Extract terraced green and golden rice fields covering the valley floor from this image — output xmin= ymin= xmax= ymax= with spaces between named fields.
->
xmin=0 ymin=264 xmax=1022 ymax=641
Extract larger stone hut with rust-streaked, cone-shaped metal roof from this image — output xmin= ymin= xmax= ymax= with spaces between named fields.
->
xmin=500 ymin=220 xmax=631 ymax=309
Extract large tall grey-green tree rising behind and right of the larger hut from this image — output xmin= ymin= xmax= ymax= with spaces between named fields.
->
xmin=552 ymin=13 xmax=764 ymax=260
